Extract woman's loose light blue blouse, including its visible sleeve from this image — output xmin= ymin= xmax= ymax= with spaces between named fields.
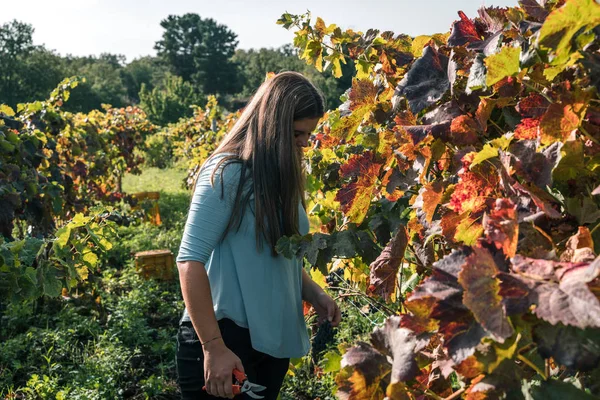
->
xmin=177 ymin=154 xmax=310 ymax=358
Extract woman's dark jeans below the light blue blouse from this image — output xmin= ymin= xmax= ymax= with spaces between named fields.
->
xmin=177 ymin=318 xmax=290 ymax=400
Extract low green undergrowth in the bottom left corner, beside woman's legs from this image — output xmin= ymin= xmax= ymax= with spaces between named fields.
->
xmin=0 ymin=265 xmax=182 ymax=399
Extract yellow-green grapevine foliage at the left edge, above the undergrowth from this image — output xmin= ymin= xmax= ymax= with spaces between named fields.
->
xmin=0 ymin=79 xmax=154 ymax=312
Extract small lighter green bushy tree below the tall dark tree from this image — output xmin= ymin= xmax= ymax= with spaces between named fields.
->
xmin=140 ymin=74 xmax=205 ymax=125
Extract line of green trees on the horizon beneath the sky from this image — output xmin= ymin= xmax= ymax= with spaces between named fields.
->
xmin=0 ymin=13 xmax=354 ymax=125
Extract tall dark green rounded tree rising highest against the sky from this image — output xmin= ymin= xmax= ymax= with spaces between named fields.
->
xmin=155 ymin=13 xmax=239 ymax=94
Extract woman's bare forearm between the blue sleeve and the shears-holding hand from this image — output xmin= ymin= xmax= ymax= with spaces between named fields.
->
xmin=177 ymin=261 xmax=223 ymax=350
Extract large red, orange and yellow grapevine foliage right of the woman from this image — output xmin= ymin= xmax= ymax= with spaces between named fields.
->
xmin=278 ymin=0 xmax=600 ymax=399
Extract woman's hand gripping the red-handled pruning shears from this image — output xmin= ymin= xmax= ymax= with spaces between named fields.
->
xmin=203 ymin=339 xmax=245 ymax=399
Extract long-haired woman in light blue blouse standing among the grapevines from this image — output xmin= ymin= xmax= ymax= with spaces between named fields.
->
xmin=177 ymin=72 xmax=341 ymax=399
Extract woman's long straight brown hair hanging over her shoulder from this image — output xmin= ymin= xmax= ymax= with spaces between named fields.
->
xmin=212 ymin=72 xmax=324 ymax=255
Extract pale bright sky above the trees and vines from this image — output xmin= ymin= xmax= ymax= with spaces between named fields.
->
xmin=0 ymin=0 xmax=517 ymax=61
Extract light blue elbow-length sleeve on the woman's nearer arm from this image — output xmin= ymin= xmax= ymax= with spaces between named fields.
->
xmin=177 ymin=157 xmax=241 ymax=264
